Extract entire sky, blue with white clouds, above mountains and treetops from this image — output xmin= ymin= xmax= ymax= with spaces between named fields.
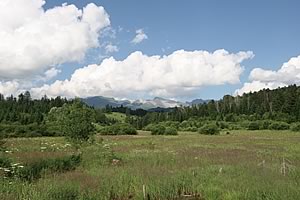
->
xmin=0 ymin=0 xmax=300 ymax=100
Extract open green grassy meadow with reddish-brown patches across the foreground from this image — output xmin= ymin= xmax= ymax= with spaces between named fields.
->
xmin=0 ymin=131 xmax=300 ymax=200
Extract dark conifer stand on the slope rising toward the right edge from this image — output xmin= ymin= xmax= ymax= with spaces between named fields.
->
xmin=127 ymin=85 xmax=300 ymax=128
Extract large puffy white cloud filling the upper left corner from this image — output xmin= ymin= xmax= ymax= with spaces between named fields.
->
xmin=0 ymin=0 xmax=110 ymax=79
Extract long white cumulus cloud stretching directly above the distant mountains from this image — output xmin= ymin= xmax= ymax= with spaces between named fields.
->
xmin=32 ymin=49 xmax=254 ymax=98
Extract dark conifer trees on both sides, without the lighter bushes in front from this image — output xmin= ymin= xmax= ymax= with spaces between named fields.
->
xmin=0 ymin=85 xmax=300 ymax=135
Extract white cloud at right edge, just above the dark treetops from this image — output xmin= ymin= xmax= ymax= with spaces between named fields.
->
xmin=235 ymin=56 xmax=300 ymax=95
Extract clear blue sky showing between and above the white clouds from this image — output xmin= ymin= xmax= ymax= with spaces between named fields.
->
xmin=0 ymin=0 xmax=300 ymax=99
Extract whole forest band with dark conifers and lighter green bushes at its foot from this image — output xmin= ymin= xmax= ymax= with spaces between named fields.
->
xmin=0 ymin=85 xmax=300 ymax=137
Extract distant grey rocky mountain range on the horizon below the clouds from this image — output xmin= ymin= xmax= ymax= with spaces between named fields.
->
xmin=82 ymin=96 xmax=209 ymax=110
